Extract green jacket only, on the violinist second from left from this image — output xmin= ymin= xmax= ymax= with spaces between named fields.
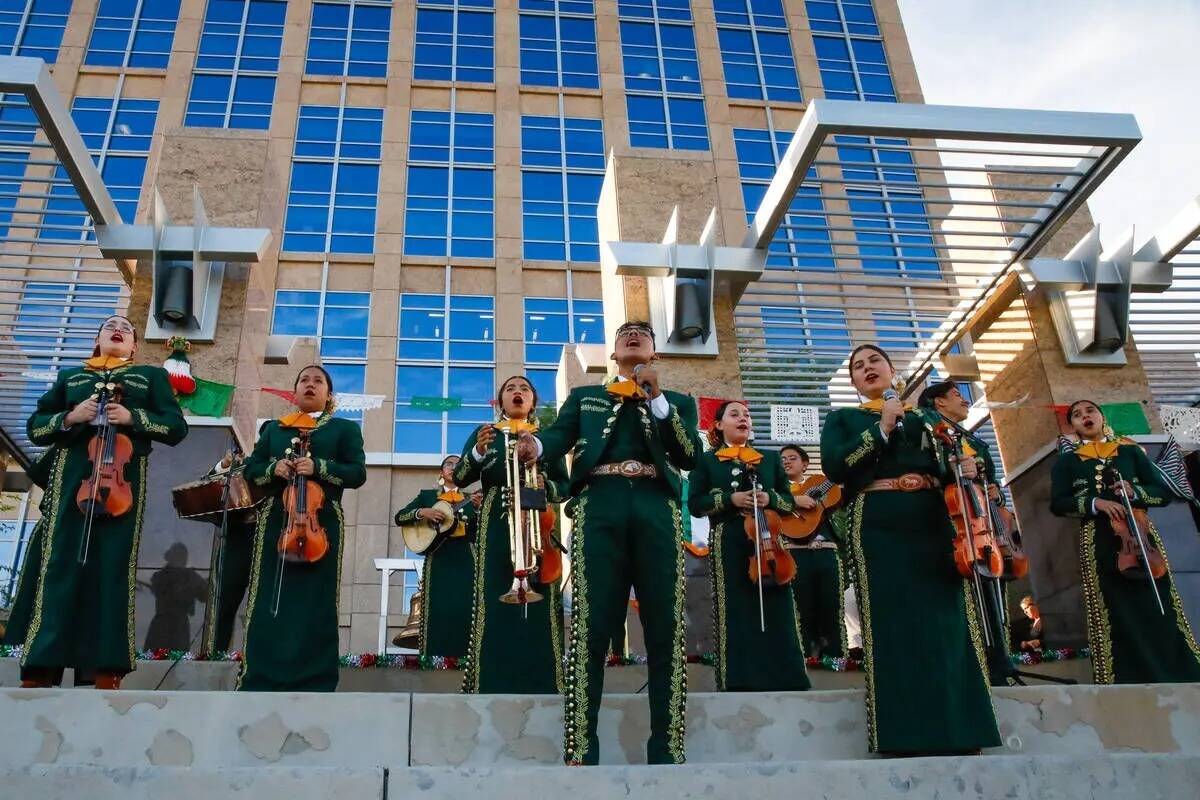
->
xmin=245 ymin=414 xmax=367 ymax=501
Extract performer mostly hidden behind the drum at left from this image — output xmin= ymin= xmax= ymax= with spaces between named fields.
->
xmin=204 ymin=451 xmax=258 ymax=655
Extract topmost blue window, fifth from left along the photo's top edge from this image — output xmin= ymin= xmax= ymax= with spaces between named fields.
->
xmin=413 ymin=0 xmax=496 ymax=83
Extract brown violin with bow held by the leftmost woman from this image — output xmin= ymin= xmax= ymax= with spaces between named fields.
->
xmin=76 ymin=381 xmax=133 ymax=564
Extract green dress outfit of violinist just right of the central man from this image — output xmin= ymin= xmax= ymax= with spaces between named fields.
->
xmin=688 ymin=447 xmax=811 ymax=692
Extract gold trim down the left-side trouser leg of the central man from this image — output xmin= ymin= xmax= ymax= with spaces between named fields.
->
xmin=563 ymin=492 xmax=589 ymax=763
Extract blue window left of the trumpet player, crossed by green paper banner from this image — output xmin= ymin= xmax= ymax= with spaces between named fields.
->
xmin=392 ymin=293 xmax=496 ymax=455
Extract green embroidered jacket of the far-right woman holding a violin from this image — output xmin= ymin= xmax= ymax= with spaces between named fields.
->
xmin=1050 ymin=443 xmax=1171 ymax=518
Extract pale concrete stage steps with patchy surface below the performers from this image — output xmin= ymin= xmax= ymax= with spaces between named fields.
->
xmin=0 ymin=684 xmax=1200 ymax=800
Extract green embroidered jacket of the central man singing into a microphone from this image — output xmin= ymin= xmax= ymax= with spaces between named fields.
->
xmin=538 ymin=385 xmax=703 ymax=497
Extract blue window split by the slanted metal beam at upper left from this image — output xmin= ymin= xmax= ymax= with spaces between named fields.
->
xmin=38 ymin=97 xmax=158 ymax=241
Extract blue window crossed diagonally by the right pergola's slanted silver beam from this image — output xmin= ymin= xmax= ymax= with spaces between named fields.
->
xmin=733 ymin=128 xmax=834 ymax=271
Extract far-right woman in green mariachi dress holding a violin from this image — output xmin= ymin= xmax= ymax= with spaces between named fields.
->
xmin=1050 ymin=399 xmax=1200 ymax=684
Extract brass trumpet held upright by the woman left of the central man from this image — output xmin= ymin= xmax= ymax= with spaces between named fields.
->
xmin=496 ymin=419 xmax=546 ymax=604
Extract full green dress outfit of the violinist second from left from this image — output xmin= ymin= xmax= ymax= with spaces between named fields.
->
xmin=238 ymin=414 xmax=367 ymax=692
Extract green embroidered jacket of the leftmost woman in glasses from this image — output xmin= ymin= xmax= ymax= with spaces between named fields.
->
xmin=25 ymin=365 xmax=187 ymax=456
